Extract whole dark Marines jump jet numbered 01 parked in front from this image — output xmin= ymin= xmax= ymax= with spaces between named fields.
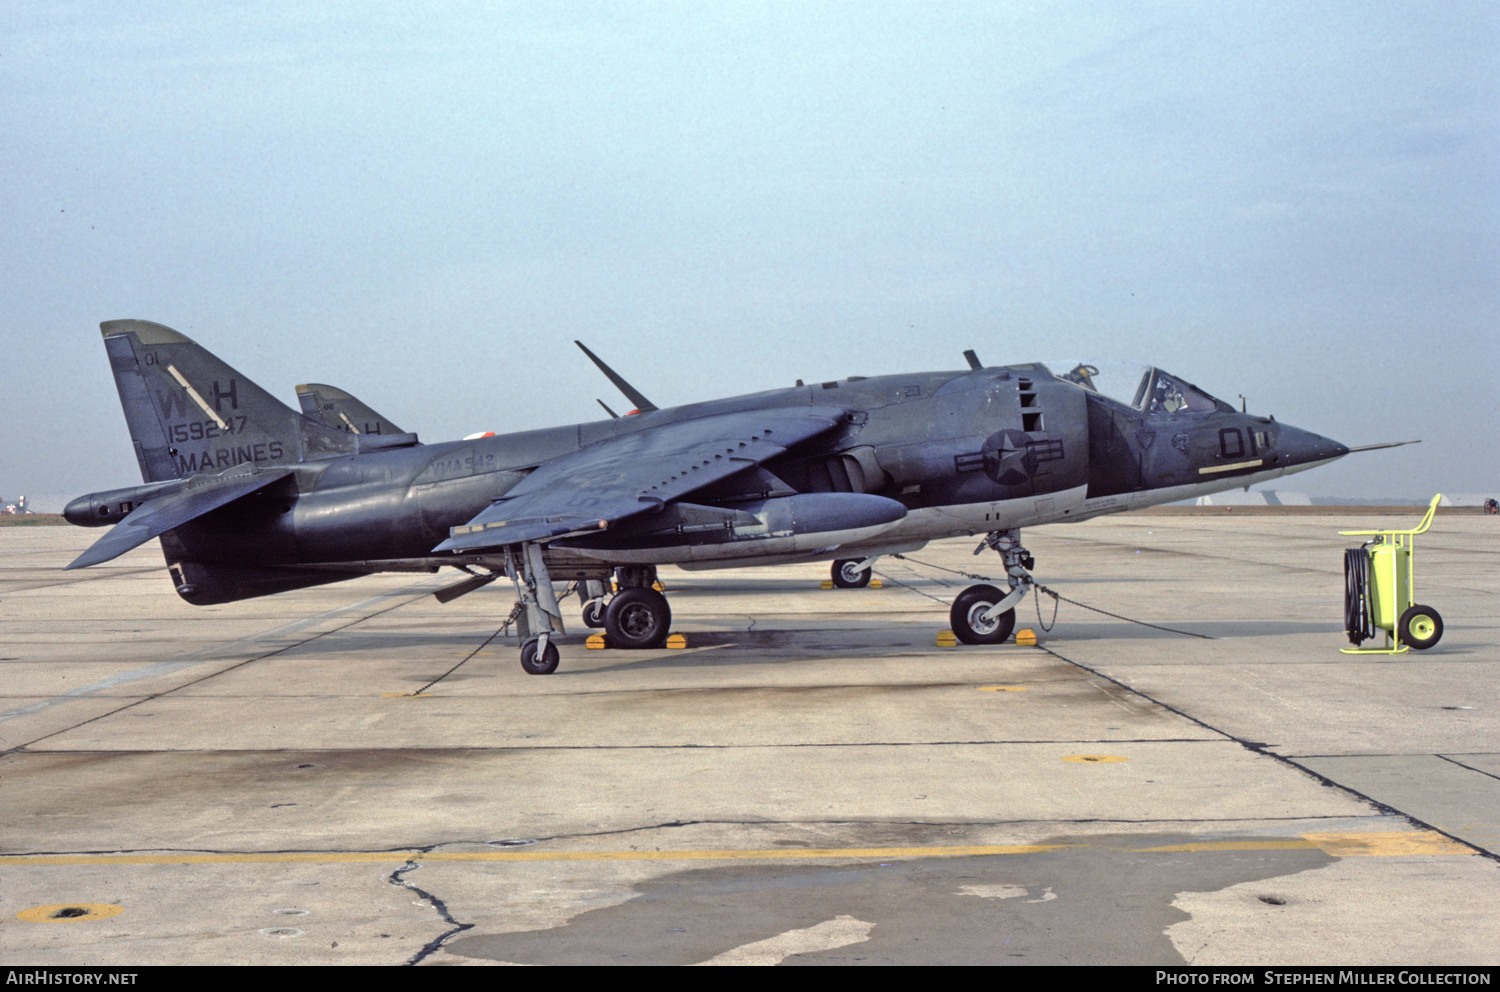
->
xmin=65 ymin=320 xmax=1350 ymax=674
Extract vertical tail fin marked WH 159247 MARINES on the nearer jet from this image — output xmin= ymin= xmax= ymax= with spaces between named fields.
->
xmin=99 ymin=320 xmax=359 ymax=482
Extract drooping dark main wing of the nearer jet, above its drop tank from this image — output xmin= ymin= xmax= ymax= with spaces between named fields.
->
xmin=434 ymin=407 xmax=848 ymax=552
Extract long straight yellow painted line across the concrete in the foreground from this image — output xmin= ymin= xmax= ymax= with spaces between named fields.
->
xmin=0 ymin=830 xmax=1473 ymax=864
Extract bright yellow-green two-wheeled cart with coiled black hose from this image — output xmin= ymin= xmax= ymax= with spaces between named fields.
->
xmin=1338 ymin=494 xmax=1443 ymax=654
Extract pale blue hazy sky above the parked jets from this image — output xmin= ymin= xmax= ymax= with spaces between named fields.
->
xmin=0 ymin=0 xmax=1500 ymax=497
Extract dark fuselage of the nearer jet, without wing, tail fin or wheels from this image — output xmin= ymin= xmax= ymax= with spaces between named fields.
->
xmin=69 ymin=357 xmax=1343 ymax=602
